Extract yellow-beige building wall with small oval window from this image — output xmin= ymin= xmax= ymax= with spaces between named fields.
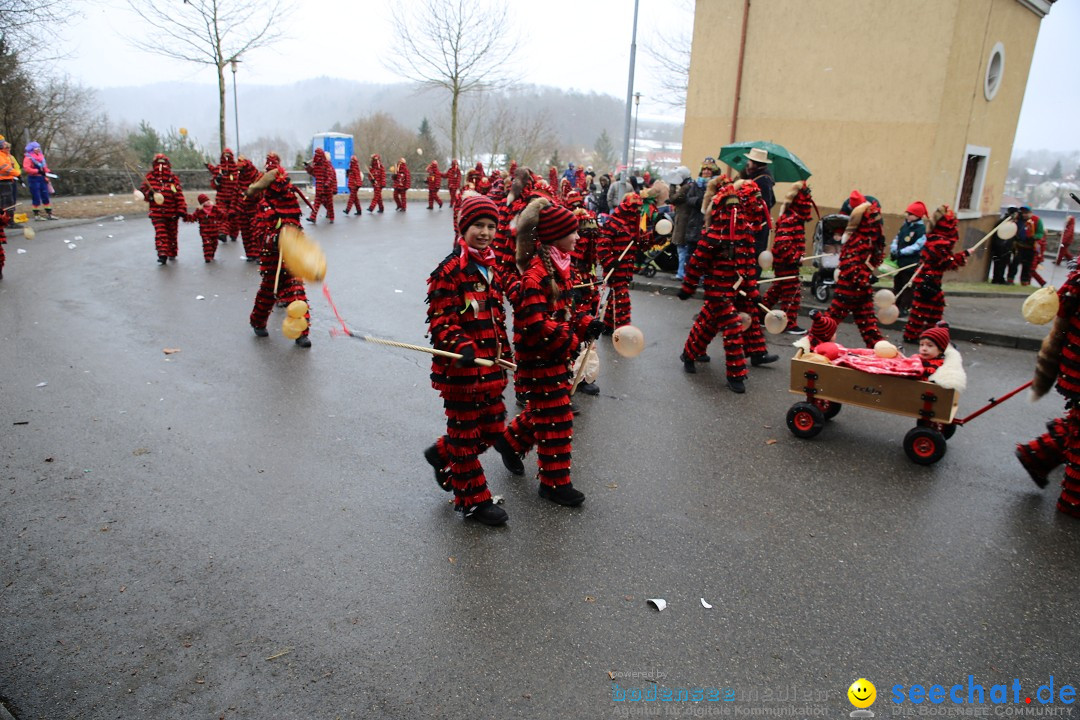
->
xmin=683 ymin=0 xmax=1040 ymax=275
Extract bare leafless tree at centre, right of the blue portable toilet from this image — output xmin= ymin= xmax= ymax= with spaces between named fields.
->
xmin=388 ymin=0 xmax=515 ymax=158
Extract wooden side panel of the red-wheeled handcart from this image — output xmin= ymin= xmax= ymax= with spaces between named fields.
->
xmin=791 ymin=357 xmax=960 ymax=422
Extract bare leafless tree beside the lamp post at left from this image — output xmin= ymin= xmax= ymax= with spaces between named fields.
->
xmin=127 ymin=0 xmax=289 ymax=155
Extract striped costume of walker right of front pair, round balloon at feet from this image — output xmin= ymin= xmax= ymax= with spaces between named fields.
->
xmin=596 ymin=192 xmax=642 ymax=331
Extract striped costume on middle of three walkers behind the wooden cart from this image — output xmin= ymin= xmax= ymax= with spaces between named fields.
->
xmin=825 ymin=202 xmax=885 ymax=348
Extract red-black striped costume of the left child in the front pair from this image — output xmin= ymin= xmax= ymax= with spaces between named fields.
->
xmin=428 ymin=245 xmax=510 ymax=507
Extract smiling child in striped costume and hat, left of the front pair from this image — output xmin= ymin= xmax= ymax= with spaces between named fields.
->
xmin=423 ymin=195 xmax=516 ymax=526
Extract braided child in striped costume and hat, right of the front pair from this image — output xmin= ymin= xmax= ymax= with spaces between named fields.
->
xmin=502 ymin=198 xmax=604 ymax=506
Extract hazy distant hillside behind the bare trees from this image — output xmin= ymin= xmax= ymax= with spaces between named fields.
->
xmin=97 ymin=78 xmax=681 ymax=158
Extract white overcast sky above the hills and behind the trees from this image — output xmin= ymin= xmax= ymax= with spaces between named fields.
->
xmin=52 ymin=0 xmax=1080 ymax=152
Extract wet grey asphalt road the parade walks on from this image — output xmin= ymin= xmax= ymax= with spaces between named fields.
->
xmin=0 ymin=203 xmax=1080 ymax=720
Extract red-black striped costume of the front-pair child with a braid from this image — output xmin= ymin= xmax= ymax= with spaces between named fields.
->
xmin=505 ymin=245 xmax=593 ymax=487
